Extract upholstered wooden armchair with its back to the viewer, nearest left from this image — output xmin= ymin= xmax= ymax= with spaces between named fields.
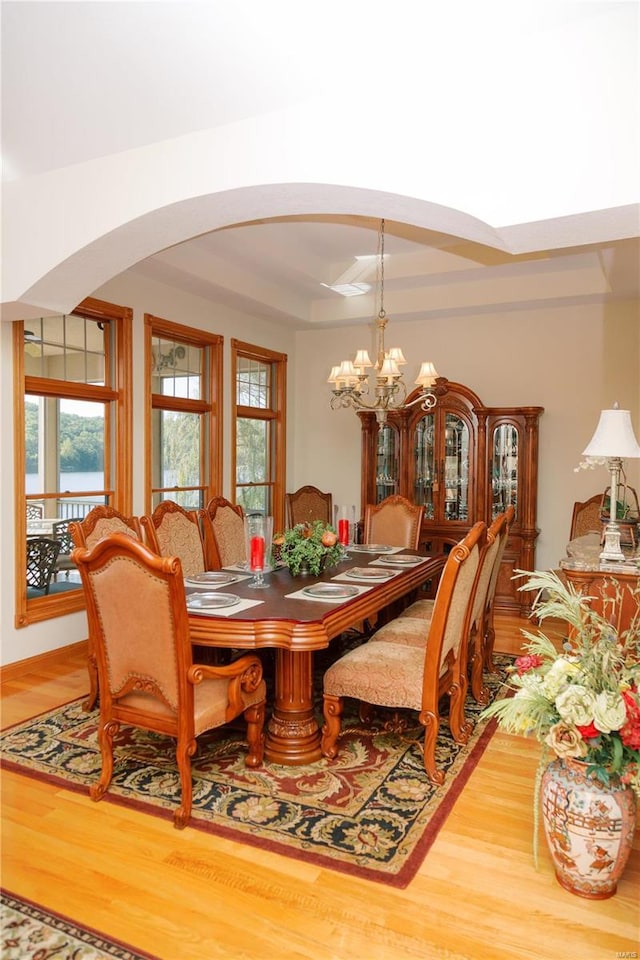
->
xmin=73 ymin=533 xmax=266 ymax=828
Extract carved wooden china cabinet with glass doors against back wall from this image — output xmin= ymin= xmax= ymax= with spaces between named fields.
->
xmin=358 ymin=377 xmax=543 ymax=613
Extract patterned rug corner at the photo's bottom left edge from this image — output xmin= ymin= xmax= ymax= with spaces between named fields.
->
xmin=0 ymin=890 xmax=157 ymax=960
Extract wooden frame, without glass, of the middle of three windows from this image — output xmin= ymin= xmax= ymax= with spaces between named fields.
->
xmin=144 ymin=313 xmax=224 ymax=513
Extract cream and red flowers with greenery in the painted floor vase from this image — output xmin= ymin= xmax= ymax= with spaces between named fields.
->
xmin=482 ymin=571 xmax=640 ymax=795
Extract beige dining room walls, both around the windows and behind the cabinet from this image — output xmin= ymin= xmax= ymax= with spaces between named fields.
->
xmin=0 ymin=274 xmax=640 ymax=663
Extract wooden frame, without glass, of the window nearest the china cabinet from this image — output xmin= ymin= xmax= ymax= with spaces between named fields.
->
xmin=231 ymin=339 xmax=288 ymax=531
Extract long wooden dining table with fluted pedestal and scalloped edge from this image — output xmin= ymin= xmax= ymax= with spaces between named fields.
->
xmin=189 ymin=549 xmax=446 ymax=766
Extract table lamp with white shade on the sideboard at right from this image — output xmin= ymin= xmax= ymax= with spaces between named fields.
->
xmin=582 ymin=403 xmax=640 ymax=563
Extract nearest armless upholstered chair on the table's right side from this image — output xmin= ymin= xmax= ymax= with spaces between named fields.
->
xmin=322 ymin=521 xmax=487 ymax=785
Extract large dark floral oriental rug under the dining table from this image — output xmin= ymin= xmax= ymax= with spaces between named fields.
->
xmin=0 ymin=656 xmax=511 ymax=887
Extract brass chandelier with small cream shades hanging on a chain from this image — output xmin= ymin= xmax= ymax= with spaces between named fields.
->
xmin=327 ymin=220 xmax=438 ymax=427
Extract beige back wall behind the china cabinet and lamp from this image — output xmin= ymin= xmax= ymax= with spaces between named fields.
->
xmin=292 ymin=303 xmax=640 ymax=567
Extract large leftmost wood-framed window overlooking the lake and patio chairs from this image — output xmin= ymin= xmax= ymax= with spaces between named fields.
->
xmin=14 ymin=298 xmax=131 ymax=626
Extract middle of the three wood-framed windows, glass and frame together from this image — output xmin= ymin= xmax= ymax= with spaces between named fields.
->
xmin=145 ymin=314 xmax=222 ymax=510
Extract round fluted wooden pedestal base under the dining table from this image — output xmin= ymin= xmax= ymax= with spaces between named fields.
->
xmin=264 ymin=649 xmax=321 ymax=766
